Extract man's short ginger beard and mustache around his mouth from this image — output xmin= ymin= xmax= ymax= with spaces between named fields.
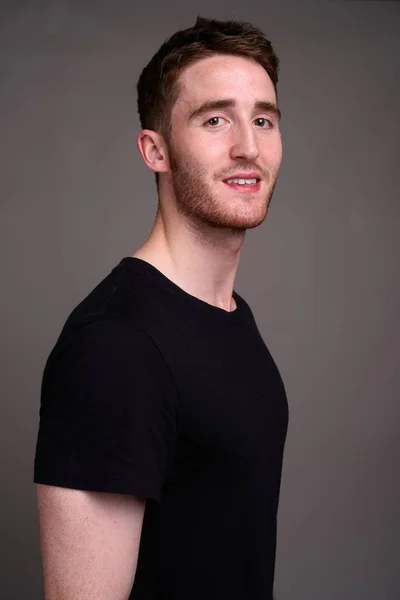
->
xmin=168 ymin=141 xmax=279 ymax=231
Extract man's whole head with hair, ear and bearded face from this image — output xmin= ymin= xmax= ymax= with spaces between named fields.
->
xmin=138 ymin=18 xmax=281 ymax=229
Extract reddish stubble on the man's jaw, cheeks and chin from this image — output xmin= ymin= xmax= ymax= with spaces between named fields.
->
xmin=169 ymin=143 xmax=278 ymax=232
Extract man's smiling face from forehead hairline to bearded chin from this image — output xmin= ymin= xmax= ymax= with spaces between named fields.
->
xmin=167 ymin=55 xmax=282 ymax=230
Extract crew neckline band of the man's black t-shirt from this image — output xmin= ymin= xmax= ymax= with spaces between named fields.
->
xmin=121 ymin=256 xmax=243 ymax=320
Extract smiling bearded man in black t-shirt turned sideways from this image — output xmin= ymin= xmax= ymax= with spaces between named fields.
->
xmin=35 ymin=18 xmax=288 ymax=600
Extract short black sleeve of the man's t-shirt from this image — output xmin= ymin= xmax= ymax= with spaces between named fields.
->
xmin=34 ymin=319 xmax=178 ymax=502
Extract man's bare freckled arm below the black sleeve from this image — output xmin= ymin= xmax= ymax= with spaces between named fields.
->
xmin=37 ymin=484 xmax=146 ymax=600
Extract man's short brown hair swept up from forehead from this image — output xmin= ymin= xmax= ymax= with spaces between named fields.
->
xmin=137 ymin=17 xmax=279 ymax=181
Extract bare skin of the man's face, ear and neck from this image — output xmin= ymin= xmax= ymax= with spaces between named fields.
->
xmin=133 ymin=55 xmax=282 ymax=311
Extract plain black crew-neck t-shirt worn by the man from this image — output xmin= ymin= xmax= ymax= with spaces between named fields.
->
xmin=34 ymin=257 xmax=288 ymax=600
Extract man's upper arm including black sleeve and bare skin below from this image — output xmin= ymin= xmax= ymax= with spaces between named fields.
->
xmin=34 ymin=319 xmax=177 ymax=600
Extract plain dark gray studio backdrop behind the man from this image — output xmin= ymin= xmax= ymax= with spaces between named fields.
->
xmin=0 ymin=0 xmax=400 ymax=600
